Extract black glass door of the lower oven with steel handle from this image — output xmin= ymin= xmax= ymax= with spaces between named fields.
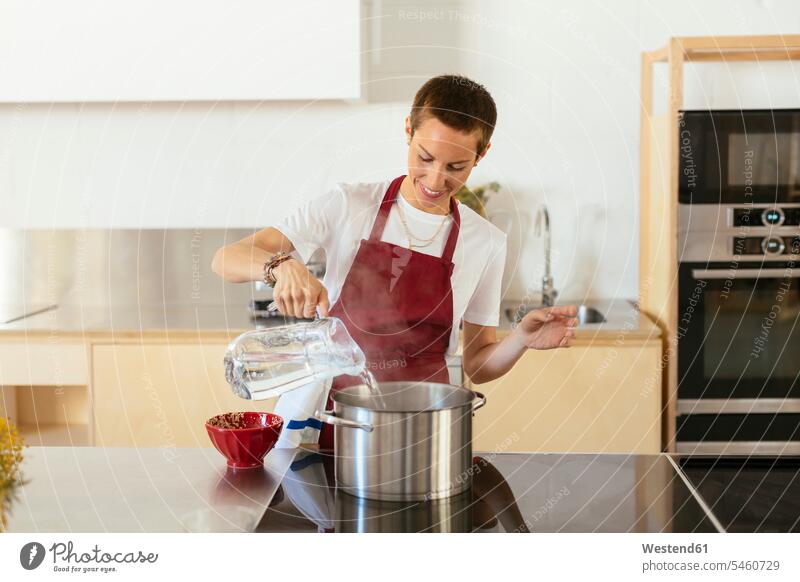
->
xmin=678 ymin=262 xmax=800 ymax=399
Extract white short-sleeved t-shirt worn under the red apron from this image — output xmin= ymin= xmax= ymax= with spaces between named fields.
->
xmin=275 ymin=180 xmax=506 ymax=355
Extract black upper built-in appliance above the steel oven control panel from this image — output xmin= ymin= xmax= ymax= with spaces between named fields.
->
xmin=678 ymin=109 xmax=800 ymax=205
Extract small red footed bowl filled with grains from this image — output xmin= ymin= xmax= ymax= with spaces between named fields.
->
xmin=206 ymin=412 xmax=283 ymax=469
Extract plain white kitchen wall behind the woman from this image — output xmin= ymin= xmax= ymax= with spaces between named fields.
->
xmin=0 ymin=0 xmax=800 ymax=299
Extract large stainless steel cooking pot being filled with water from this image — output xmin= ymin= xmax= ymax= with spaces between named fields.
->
xmin=317 ymin=382 xmax=486 ymax=501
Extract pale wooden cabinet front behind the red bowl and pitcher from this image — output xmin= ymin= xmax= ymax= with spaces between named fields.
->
xmin=92 ymin=344 xmax=274 ymax=448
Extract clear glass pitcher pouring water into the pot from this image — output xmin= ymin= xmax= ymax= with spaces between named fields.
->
xmin=225 ymin=317 xmax=366 ymax=400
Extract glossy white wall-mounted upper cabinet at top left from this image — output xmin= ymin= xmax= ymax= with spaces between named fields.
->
xmin=0 ymin=0 xmax=362 ymax=102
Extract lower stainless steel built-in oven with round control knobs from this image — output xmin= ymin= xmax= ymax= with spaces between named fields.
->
xmin=676 ymin=203 xmax=800 ymax=455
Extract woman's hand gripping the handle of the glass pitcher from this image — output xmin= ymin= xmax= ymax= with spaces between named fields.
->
xmin=272 ymin=259 xmax=330 ymax=319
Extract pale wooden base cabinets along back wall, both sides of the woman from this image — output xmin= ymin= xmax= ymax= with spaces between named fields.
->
xmin=0 ymin=326 xmax=661 ymax=453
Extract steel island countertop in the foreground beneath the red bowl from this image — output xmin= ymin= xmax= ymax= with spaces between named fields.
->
xmin=8 ymin=447 xmax=297 ymax=532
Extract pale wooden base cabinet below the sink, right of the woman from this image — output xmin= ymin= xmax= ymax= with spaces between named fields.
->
xmin=471 ymin=339 xmax=661 ymax=453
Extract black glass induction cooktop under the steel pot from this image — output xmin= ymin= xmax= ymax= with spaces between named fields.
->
xmin=257 ymin=451 xmax=724 ymax=533
